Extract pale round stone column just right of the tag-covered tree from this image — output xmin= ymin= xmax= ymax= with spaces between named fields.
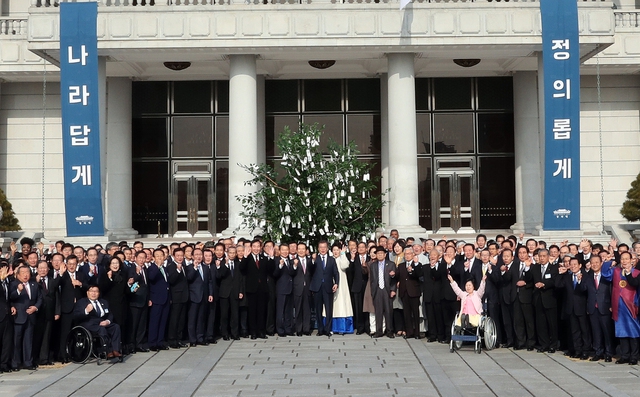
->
xmin=383 ymin=53 xmax=426 ymax=238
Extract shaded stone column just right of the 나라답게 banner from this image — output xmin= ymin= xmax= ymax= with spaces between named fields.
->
xmin=102 ymin=77 xmax=138 ymax=240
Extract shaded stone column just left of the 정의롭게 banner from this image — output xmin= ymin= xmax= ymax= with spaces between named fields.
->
xmin=511 ymin=71 xmax=544 ymax=234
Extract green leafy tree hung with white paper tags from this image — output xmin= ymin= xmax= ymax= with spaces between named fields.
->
xmin=237 ymin=123 xmax=386 ymax=246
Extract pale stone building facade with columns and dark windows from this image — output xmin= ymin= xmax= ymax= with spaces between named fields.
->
xmin=0 ymin=0 xmax=640 ymax=238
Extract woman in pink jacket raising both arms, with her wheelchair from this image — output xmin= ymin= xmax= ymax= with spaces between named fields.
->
xmin=448 ymin=275 xmax=496 ymax=354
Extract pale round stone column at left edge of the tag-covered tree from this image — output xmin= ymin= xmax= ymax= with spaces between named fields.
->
xmin=222 ymin=55 xmax=259 ymax=236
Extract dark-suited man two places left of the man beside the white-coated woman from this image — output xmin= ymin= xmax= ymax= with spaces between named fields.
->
xmin=273 ymin=244 xmax=298 ymax=337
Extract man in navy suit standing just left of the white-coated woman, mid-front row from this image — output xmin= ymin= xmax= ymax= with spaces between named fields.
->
xmin=309 ymin=240 xmax=340 ymax=337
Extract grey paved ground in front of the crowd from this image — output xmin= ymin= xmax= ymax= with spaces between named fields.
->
xmin=0 ymin=335 xmax=640 ymax=397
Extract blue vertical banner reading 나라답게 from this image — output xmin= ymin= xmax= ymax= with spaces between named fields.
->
xmin=60 ymin=2 xmax=104 ymax=236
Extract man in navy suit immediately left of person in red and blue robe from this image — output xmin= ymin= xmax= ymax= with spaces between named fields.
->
xmin=582 ymin=255 xmax=615 ymax=363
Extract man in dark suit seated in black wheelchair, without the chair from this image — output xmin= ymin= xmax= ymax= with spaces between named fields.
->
xmin=73 ymin=285 xmax=122 ymax=358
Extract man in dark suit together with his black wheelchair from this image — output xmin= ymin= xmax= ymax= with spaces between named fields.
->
xmin=67 ymin=285 xmax=122 ymax=364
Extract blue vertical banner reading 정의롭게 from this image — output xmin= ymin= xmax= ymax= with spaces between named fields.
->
xmin=540 ymin=0 xmax=580 ymax=230
